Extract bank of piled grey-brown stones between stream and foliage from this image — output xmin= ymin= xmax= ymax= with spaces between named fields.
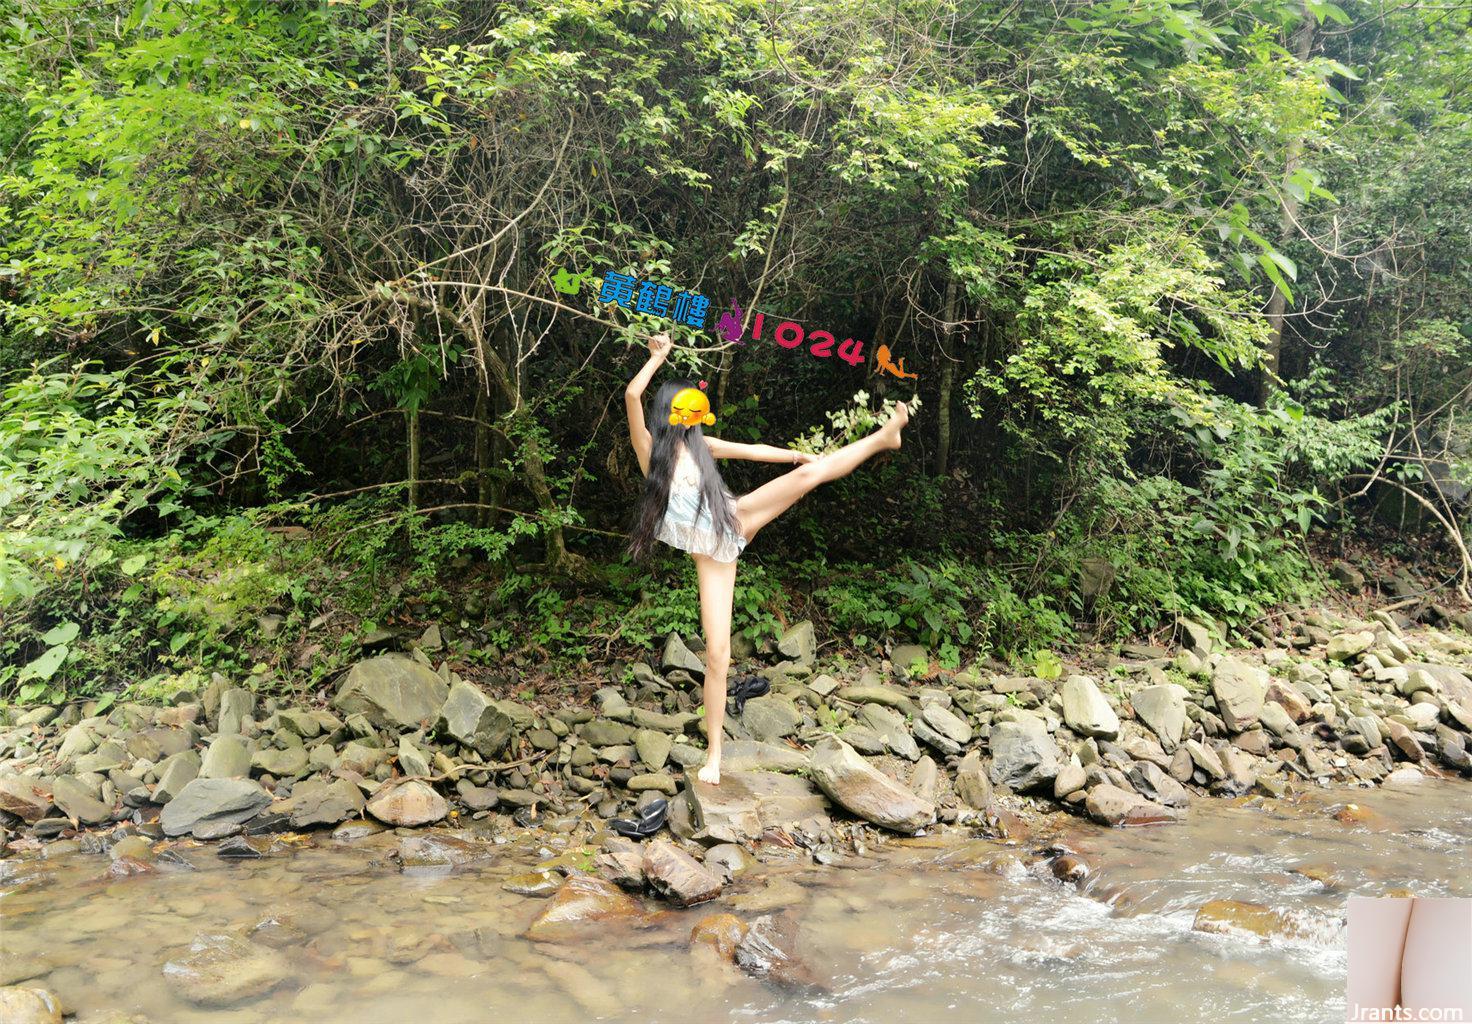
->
xmin=0 ymin=609 xmax=1472 ymax=882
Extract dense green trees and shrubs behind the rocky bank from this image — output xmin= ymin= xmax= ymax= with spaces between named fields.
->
xmin=0 ymin=0 xmax=1472 ymax=699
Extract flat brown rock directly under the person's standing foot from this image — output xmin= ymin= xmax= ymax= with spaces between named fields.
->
xmin=670 ymin=771 xmax=829 ymax=843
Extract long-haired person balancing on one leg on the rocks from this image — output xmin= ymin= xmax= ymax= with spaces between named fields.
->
xmin=624 ymin=334 xmax=910 ymax=784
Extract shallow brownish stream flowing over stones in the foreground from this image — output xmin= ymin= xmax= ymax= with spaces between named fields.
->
xmin=0 ymin=781 xmax=1472 ymax=1024
